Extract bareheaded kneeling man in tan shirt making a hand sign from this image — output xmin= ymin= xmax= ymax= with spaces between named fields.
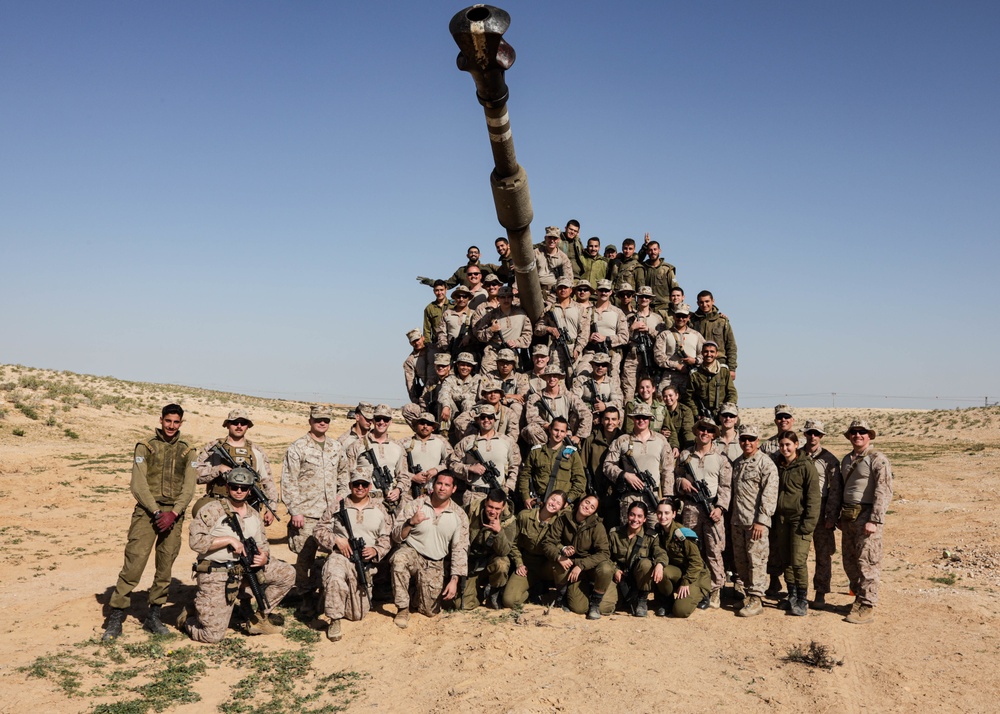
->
xmin=390 ymin=471 xmax=469 ymax=629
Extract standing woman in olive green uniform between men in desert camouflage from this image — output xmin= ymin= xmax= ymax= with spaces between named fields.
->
xmin=771 ymin=431 xmax=820 ymax=617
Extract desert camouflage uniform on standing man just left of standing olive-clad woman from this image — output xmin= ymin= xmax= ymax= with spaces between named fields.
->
xmin=731 ymin=451 xmax=778 ymax=598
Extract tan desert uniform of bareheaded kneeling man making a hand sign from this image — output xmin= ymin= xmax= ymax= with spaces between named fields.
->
xmin=390 ymin=496 xmax=469 ymax=617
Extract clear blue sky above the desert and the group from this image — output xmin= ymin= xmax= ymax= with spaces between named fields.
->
xmin=0 ymin=0 xmax=1000 ymax=407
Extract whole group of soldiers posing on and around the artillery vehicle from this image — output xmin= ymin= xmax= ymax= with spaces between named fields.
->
xmin=105 ymin=221 xmax=892 ymax=642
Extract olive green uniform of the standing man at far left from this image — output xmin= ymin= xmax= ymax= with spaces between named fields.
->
xmin=111 ymin=429 xmax=196 ymax=610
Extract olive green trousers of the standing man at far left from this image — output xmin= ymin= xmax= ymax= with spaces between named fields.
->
xmin=111 ymin=503 xmax=184 ymax=609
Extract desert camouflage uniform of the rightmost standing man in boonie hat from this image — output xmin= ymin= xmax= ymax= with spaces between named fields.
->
xmin=828 ymin=447 xmax=892 ymax=607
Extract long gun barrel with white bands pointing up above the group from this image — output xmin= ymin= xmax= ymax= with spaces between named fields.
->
xmin=448 ymin=5 xmax=543 ymax=322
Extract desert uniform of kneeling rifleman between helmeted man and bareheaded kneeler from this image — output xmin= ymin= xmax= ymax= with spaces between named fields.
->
xmin=313 ymin=498 xmax=392 ymax=621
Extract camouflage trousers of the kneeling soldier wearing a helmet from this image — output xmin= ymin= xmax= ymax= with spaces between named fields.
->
xmin=186 ymin=558 xmax=295 ymax=643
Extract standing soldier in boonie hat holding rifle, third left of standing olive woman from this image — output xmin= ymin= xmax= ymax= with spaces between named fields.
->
xmin=674 ymin=417 xmax=733 ymax=609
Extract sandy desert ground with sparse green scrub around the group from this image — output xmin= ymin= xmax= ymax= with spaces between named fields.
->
xmin=0 ymin=365 xmax=1000 ymax=713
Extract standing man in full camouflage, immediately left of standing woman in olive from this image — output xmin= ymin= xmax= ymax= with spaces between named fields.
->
xmin=730 ymin=424 xmax=778 ymax=617
